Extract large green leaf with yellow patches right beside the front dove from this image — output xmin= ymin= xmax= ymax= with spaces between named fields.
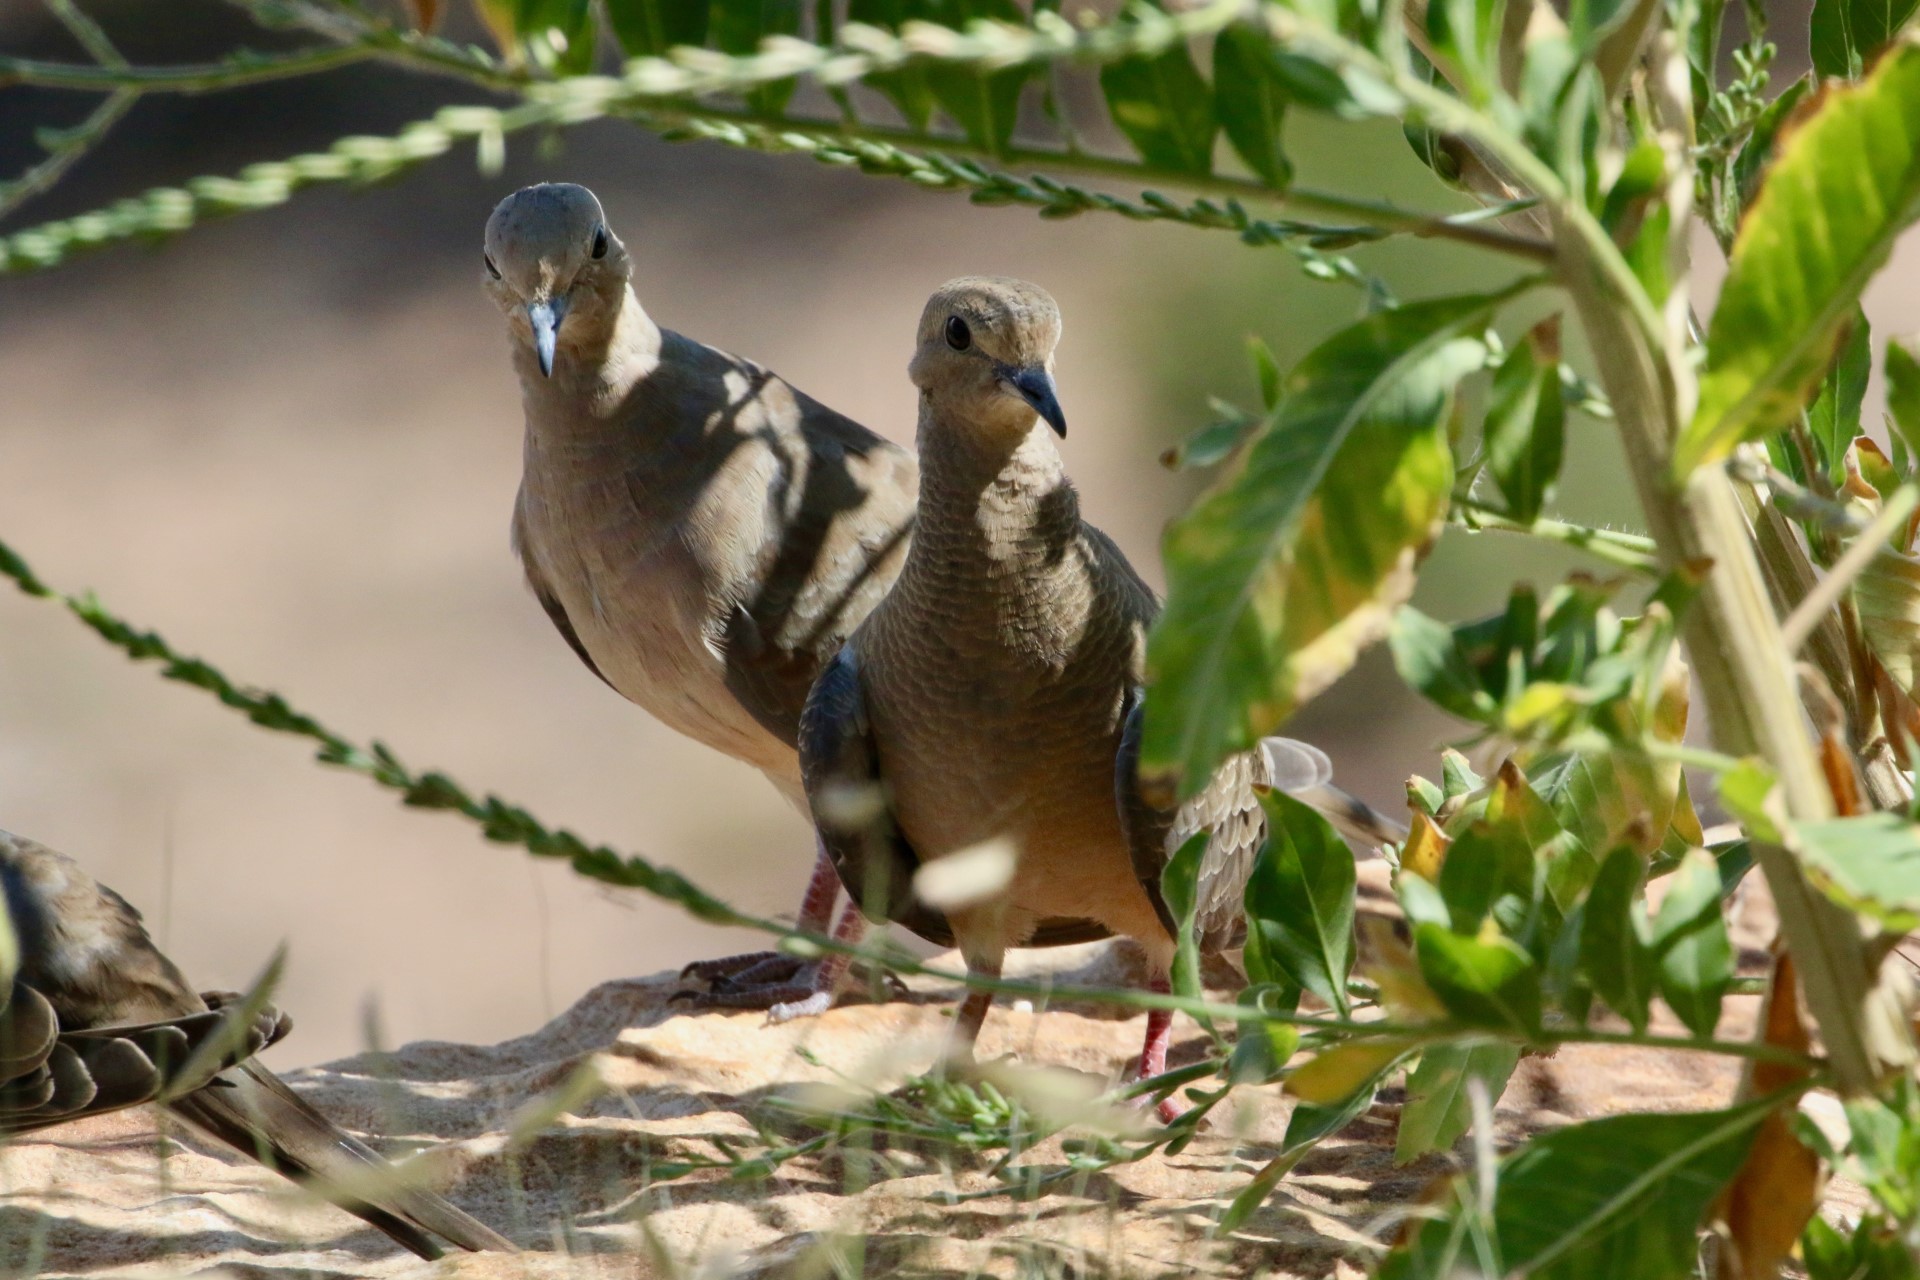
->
xmin=1140 ymin=297 xmax=1494 ymax=793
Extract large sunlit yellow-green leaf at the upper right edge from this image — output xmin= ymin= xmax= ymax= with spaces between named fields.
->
xmin=1674 ymin=42 xmax=1920 ymax=474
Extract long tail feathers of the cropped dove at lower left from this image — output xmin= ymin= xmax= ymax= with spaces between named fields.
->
xmin=167 ymin=1063 xmax=515 ymax=1259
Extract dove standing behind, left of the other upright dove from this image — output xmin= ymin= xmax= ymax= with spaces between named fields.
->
xmin=484 ymin=182 xmax=918 ymax=1007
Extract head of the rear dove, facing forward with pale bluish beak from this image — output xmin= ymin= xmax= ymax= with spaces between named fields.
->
xmin=486 ymin=182 xmax=630 ymax=378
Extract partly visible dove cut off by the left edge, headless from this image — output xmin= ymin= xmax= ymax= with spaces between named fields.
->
xmin=0 ymin=831 xmax=515 ymax=1259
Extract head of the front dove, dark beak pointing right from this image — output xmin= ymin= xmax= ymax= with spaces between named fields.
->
xmin=908 ymin=276 xmax=1068 ymax=436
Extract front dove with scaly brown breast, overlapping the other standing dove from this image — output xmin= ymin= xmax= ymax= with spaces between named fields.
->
xmin=801 ymin=276 xmax=1396 ymax=1113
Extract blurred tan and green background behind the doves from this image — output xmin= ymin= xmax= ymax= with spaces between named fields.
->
xmin=0 ymin=0 xmax=1889 ymax=1061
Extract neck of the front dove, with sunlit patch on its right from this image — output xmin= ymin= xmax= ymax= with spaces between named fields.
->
xmin=908 ymin=401 xmax=1081 ymax=581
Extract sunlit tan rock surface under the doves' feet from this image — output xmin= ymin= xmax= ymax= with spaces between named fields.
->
xmin=0 ymin=932 xmax=1850 ymax=1280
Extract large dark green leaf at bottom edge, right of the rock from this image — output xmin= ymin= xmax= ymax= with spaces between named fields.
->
xmin=1379 ymin=1098 xmax=1780 ymax=1280
